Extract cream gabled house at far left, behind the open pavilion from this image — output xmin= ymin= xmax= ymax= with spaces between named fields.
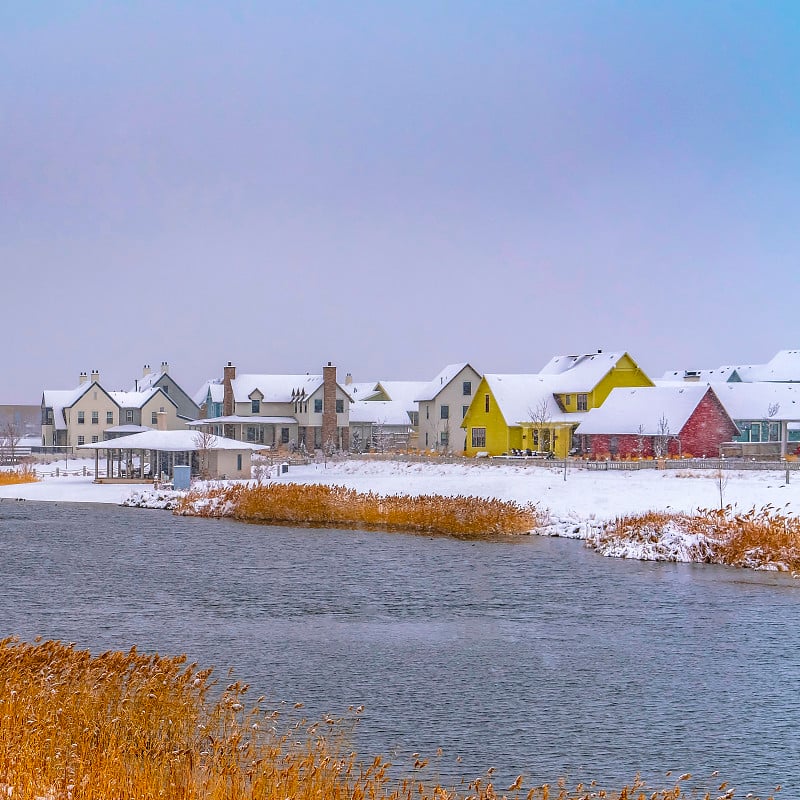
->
xmin=41 ymin=371 xmax=185 ymax=448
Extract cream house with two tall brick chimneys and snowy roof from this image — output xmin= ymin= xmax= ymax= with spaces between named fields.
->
xmin=191 ymin=361 xmax=352 ymax=451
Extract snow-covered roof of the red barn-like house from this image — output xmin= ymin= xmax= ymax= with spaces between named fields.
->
xmin=577 ymin=384 xmax=713 ymax=436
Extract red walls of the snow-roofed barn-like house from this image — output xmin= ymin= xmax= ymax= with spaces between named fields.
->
xmin=589 ymin=389 xmax=738 ymax=457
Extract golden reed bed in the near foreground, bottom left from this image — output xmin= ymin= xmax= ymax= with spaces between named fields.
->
xmin=0 ymin=638 xmax=776 ymax=800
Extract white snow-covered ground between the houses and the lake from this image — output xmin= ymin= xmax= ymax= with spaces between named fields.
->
xmin=0 ymin=459 xmax=800 ymax=526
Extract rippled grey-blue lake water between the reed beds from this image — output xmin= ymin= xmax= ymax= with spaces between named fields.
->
xmin=0 ymin=501 xmax=800 ymax=797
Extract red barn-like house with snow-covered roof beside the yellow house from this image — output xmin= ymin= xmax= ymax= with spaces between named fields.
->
xmin=577 ymin=384 xmax=739 ymax=458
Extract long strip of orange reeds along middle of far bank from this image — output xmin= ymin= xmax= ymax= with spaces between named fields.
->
xmin=175 ymin=483 xmax=542 ymax=538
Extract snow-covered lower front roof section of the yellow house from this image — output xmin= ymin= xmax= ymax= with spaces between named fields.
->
xmin=483 ymin=373 xmax=586 ymax=425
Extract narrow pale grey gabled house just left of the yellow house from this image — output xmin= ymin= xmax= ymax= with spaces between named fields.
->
xmin=414 ymin=362 xmax=481 ymax=453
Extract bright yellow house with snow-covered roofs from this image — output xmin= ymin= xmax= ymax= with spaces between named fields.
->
xmin=462 ymin=351 xmax=654 ymax=458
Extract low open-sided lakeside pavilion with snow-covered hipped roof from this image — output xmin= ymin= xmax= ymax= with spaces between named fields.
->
xmin=77 ymin=429 xmax=264 ymax=483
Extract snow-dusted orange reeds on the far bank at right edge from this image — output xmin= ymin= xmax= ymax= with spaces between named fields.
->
xmin=600 ymin=505 xmax=800 ymax=573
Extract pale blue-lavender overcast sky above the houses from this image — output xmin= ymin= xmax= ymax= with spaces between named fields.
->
xmin=0 ymin=0 xmax=800 ymax=403
